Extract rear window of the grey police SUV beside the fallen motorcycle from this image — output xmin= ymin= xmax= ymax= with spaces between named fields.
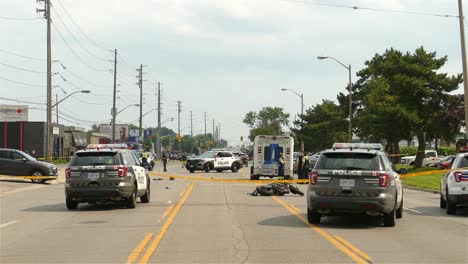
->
xmin=316 ymin=152 xmax=380 ymax=171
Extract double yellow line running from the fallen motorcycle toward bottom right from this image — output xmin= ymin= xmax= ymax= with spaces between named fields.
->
xmin=272 ymin=196 xmax=371 ymax=264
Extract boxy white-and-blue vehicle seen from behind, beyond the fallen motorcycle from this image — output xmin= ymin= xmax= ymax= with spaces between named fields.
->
xmin=250 ymin=135 xmax=294 ymax=180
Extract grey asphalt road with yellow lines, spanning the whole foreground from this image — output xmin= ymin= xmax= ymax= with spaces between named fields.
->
xmin=0 ymin=163 xmax=468 ymax=263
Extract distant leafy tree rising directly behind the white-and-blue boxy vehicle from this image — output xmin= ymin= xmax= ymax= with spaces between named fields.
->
xmin=242 ymin=106 xmax=289 ymax=141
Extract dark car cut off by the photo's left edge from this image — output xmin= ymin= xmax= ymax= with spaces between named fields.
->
xmin=0 ymin=148 xmax=58 ymax=183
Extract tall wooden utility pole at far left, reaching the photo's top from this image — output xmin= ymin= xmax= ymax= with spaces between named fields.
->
xmin=36 ymin=0 xmax=52 ymax=162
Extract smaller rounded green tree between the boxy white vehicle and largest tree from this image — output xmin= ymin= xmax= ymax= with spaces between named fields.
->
xmin=292 ymin=100 xmax=348 ymax=151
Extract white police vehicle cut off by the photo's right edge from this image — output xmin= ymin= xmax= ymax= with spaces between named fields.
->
xmin=440 ymin=153 xmax=468 ymax=214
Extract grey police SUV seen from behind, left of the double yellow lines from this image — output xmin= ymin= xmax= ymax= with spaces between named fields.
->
xmin=65 ymin=148 xmax=151 ymax=210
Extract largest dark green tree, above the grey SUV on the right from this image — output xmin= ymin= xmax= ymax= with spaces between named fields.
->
xmin=354 ymin=47 xmax=462 ymax=167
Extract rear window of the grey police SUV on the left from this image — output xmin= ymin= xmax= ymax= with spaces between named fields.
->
xmin=70 ymin=151 xmax=122 ymax=166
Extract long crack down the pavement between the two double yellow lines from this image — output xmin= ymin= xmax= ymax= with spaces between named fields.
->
xmin=223 ymin=183 xmax=250 ymax=264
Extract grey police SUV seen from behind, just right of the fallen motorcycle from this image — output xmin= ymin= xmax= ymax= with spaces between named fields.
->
xmin=307 ymin=143 xmax=406 ymax=226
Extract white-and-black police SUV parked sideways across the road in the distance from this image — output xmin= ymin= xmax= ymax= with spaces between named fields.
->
xmin=185 ymin=150 xmax=242 ymax=173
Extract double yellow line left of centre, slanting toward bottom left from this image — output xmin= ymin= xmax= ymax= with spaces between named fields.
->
xmin=126 ymin=176 xmax=195 ymax=264
